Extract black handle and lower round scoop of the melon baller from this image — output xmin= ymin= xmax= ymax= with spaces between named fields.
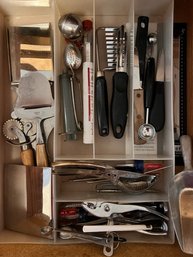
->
xmin=138 ymin=57 xmax=156 ymax=141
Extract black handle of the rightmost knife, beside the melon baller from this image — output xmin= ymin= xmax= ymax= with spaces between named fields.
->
xmin=149 ymin=81 xmax=165 ymax=132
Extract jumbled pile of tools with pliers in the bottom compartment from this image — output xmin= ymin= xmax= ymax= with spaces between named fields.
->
xmin=41 ymin=200 xmax=169 ymax=256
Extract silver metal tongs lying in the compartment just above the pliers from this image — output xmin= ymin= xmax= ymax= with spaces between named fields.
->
xmin=52 ymin=161 xmax=157 ymax=193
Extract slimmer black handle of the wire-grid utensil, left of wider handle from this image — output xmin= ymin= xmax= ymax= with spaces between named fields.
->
xmin=95 ymin=76 xmax=109 ymax=136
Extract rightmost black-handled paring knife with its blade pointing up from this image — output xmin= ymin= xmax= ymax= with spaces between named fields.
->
xmin=149 ymin=50 xmax=165 ymax=132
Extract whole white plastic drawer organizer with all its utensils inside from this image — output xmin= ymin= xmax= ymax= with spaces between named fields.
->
xmin=0 ymin=0 xmax=178 ymax=255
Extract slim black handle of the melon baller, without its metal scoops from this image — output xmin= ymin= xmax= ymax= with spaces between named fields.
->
xmin=144 ymin=57 xmax=155 ymax=108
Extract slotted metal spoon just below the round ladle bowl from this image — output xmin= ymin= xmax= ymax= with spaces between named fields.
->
xmin=64 ymin=43 xmax=82 ymax=130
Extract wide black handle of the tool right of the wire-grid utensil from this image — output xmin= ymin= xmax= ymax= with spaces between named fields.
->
xmin=111 ymin=72 xmax=128 ymax=138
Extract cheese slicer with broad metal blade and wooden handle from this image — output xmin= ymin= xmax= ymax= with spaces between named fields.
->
xmin=12 ymin=72 xmax=54 ymax=167
